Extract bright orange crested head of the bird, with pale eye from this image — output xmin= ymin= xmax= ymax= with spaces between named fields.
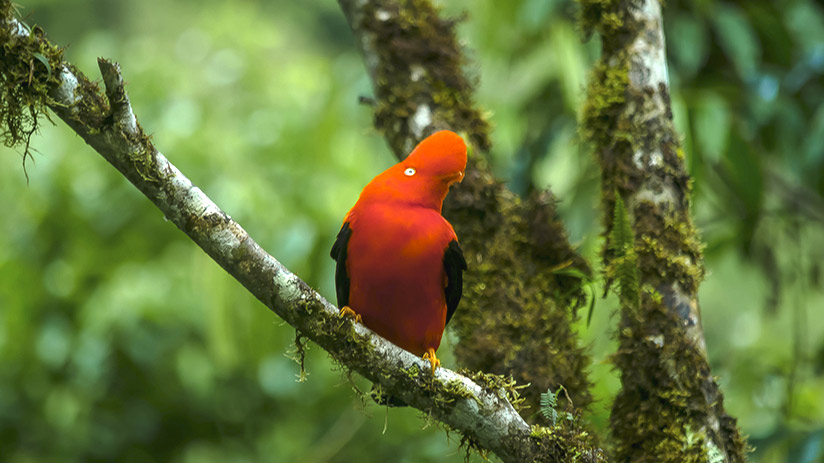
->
xmin=361 ymin=130 xmax=466 ymax=212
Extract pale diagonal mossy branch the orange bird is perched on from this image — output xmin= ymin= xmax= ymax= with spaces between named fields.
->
xmin=0 ymin=6 xmax=603 ymax=462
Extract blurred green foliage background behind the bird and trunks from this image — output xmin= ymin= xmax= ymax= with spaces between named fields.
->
xmin=0 ymin=0 xmax=824 ymax=463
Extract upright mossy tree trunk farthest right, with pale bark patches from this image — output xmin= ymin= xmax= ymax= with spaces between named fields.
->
xmin=581 ymin=0 xmax=747 ymax=462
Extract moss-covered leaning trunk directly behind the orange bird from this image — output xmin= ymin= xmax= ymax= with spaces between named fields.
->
xmin=339 ymin=0 xmax=592 ymax=420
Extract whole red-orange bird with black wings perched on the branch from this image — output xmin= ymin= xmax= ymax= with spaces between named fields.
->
xmin=331 ymin=130 xmax=466 ymax=374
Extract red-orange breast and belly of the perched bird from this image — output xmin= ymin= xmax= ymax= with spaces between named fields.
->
xmin=347 ymin=204 xmax=456 ymax=355
